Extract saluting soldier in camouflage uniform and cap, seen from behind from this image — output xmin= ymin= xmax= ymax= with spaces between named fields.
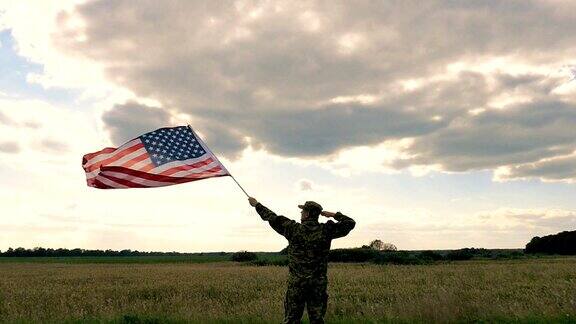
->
xmin=248 ymin=197 xmax=356 ymax=323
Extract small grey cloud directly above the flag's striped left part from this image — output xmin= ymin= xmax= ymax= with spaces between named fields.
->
xmin=102 ymin=102 xmax=170 ymax=145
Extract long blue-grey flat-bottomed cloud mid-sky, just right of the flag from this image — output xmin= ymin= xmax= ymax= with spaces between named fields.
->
xmin=197 ymin=104 xmax=445 ymax=157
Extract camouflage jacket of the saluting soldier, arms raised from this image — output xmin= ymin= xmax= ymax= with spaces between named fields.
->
xmin=256 ymin=203 xmax=356 ymax=279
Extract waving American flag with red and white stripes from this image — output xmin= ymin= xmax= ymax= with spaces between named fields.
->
xmin=82 ymin=126 xmax=230 ymax=189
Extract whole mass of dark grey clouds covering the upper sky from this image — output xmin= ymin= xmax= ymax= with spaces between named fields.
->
xmin=54 ymin=0 xmax=576 ymax=178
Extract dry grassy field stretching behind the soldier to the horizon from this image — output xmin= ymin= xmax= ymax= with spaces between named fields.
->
xmin=0 ymin=258 xmax=576 ymax=323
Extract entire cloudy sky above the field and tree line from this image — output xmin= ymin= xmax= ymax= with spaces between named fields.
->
xmin=0 ymin=0 xmax=576 ymax=252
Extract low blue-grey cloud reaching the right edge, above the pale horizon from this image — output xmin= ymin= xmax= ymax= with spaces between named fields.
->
xmin=400 ymin=101 xmax=576 ymax=171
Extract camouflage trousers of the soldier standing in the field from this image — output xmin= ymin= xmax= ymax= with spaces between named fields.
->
xmin=284 ymin=276 xmax=328 ymax=324
